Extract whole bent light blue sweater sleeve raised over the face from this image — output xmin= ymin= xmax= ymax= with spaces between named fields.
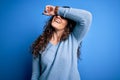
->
xmin=58 ymin=7 xmax=92 ymax=43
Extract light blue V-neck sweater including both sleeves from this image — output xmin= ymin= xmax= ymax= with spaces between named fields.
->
xmin=31 ymin=7 xmax=92 ymax=80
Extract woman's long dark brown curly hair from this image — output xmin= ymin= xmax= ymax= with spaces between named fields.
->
xmin=32 ymin=6 xmax=82 ymax=58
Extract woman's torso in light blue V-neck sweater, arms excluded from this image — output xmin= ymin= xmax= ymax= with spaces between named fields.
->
xmin=39 ymin=34 xmax=80 ymax=80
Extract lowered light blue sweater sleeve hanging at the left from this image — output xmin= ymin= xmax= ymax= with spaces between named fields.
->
xmin=31 ymin=56 xmax=40 ymax=80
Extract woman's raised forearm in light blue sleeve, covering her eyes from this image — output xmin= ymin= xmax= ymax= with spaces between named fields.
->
xmin=57 ymin=7 xmax=92 ymax=25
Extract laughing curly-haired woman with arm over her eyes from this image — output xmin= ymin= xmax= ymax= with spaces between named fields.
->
xmin=31 ymin=5 xmax=92 ymax=80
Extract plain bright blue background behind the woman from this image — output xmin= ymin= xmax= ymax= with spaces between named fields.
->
xmin=0 ymin=0 xmax=120 ymax=80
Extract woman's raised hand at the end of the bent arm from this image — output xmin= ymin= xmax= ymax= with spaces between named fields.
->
xmin=43 ymin=5 xmax=55 ymax=16
